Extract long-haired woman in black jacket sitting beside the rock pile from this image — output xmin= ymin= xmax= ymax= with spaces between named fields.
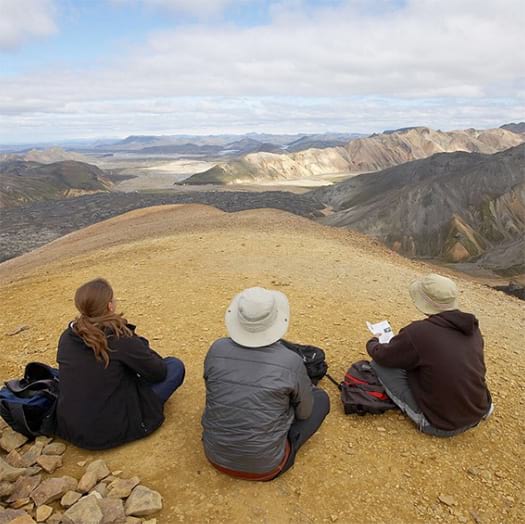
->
xmin=57 ymin=278 xmax=185 ymax=450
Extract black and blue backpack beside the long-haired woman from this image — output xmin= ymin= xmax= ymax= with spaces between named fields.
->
xmin=0 ymin=362 xmax=59 ymax=438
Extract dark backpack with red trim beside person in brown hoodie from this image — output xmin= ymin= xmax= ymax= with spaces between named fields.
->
xmin=328 ymin=360 xmax=397 ymax=415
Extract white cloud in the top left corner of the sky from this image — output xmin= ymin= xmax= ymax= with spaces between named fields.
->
xmin=0 ymin=0 xmax=56 ymax=51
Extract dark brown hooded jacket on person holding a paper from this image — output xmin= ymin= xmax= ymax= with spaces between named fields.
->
xmin=366 ymin=310 xmax=490 ymax=430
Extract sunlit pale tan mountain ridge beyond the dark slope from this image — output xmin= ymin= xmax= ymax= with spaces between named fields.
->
xmin=184 ymin=127 xmax=525 ymax=184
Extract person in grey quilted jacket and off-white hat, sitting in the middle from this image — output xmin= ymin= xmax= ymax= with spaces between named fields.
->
xmin=202 ymin=287 xmax=330 ymax=480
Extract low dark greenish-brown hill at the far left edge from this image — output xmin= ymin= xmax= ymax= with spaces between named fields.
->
xmin=0 ymin=160 xmax=111 ymax=207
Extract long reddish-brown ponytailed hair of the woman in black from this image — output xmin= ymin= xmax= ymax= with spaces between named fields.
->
xmin=73 ymin=278 xmax=133 ymax=367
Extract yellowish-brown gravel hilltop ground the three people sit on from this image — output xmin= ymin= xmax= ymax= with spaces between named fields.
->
xmin=0 ymin=206 xmax=525 ymax=524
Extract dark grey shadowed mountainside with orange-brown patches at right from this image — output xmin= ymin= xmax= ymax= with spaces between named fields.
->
xmin=310 ymin=144 xmax=525 ymax=275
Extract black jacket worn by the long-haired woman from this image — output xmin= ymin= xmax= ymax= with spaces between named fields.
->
xmin=57 ymin=325 xmax=166 ymax=450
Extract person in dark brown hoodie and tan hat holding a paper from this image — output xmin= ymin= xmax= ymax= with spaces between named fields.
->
xmin=366 ymin=274 xmax=493 ymax=437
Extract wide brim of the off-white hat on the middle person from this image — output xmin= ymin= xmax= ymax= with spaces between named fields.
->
xmin=224 ymin=291 xmax=290 ymax=348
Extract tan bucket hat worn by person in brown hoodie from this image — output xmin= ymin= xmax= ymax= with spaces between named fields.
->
xmin=409 ymin=273 xmax=458 ymax=315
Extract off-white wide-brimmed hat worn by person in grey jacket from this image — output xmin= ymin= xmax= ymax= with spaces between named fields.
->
xmin=224 ymin=287 xmax=290 ymax=348
